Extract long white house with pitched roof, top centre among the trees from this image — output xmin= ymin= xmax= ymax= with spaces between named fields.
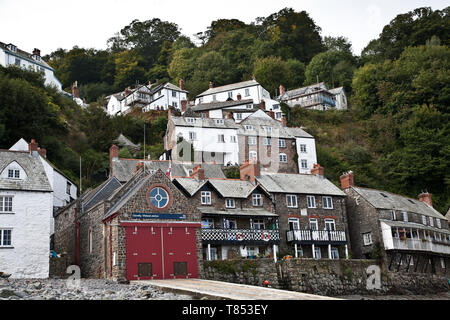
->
xmin=195 ymin=80 xmax=283 ymax=121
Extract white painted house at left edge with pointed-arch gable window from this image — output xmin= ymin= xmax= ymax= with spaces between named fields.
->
xmin=0 ymin=150 xmax=53 ymax=278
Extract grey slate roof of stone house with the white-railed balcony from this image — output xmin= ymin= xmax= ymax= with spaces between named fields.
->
xmin=256 ymin=173 xmax=346 ymax=197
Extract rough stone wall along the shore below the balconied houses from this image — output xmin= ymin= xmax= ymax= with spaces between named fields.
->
xmin=202 ymin=259 xmax=450 ymax=296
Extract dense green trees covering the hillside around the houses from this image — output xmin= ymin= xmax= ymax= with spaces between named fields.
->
xmin=0 ymin=8 xmax=450 ymax=212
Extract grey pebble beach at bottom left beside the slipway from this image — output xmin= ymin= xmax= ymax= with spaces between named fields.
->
xmin=0 ymin=279 xmax=193 ymax=300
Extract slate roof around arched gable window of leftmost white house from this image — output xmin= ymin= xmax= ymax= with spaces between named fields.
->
xmin=0 ymin=150 xmax=53 ymax=192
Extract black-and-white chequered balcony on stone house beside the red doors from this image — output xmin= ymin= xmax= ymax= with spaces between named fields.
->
xmin=202 ymin=229 xmax=280 ymax=245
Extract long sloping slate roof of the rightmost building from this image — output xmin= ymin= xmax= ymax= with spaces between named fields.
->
xmin=352 ymin=187 xmax=445 ymax=219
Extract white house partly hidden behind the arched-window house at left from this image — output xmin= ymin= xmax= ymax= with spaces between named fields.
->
xmin=9 ymin=139 xmax=78 ymax=235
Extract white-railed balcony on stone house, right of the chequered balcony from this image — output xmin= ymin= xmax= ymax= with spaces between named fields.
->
xmin=286 ymin=230 xmax=347 ymax=245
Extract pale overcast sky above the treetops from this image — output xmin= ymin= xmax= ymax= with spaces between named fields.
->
xmin=0 ymin=0 xmax=449 ymax=55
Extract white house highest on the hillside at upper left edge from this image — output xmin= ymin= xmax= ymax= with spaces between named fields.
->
xmin=0 ymin=42 xmax=62 ymax=91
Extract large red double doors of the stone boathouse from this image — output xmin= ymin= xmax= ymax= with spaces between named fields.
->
xmin=123 ymin=223 xmax=200 ymax=280
